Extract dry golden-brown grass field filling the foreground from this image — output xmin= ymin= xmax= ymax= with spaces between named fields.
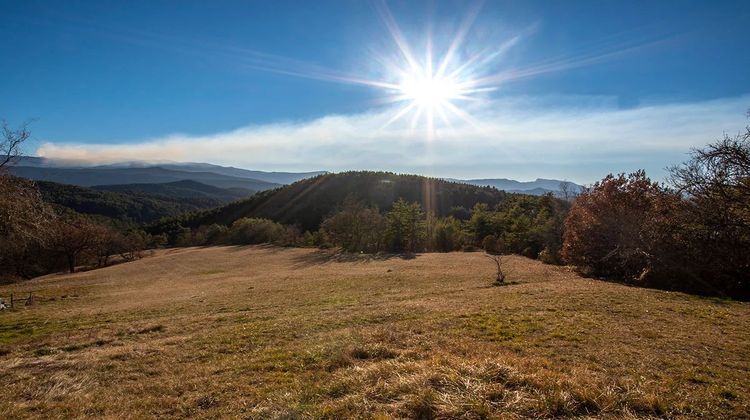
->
xmin=0 ymin=247 xmax=750 ymax=418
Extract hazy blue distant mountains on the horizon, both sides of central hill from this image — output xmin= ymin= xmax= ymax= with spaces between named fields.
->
xmin=10 ymin=157 xmax=582 ymax=200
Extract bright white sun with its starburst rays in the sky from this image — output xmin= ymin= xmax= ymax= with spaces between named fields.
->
xmin=239 ymin=1 xmax=512 ymax=135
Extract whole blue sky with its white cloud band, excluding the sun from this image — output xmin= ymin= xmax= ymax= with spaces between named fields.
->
xmin=0 ymin=0 xmax=750 ymax=182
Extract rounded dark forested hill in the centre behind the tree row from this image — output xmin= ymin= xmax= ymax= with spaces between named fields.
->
xmin=151 ymin=172 xmax=507 ymax=233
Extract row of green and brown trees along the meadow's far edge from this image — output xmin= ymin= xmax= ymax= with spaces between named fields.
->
xmin=154 ymin=194 xmax=569 ymax=262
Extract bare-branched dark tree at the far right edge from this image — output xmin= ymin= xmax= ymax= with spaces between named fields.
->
xmin=669 ymin=115 xmax=750 ymax=296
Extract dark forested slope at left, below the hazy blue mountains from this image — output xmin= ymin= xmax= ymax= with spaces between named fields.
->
xmin=37 ymin=181 xmax=238 ymax=224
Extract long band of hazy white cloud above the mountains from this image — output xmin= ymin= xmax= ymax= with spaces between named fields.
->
xmin=37 ymin=96 xmax=750 ymax=182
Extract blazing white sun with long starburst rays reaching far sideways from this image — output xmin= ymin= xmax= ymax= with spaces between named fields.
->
xmin=228 ymin=0 xmax=636 ymax=140
